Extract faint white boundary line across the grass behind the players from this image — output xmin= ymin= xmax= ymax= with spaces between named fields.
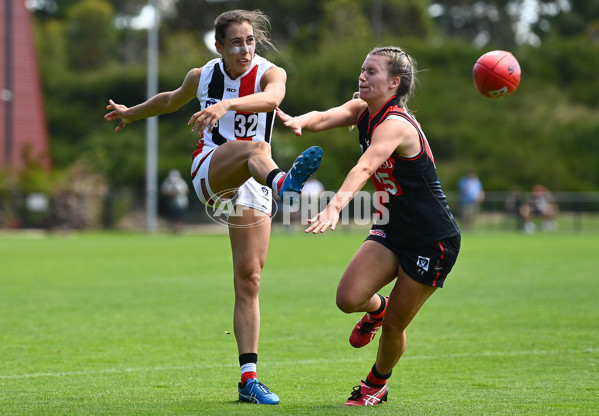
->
xmin=0 ymin=348 xmax=599 ymax=380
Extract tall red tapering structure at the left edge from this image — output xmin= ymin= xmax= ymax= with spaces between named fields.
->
xmin=0 ymin=0 xmax=51 ymax=171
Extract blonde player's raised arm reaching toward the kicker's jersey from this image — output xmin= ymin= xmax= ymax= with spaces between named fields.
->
xmin=277 ymin=99 xmax=366 ymax=136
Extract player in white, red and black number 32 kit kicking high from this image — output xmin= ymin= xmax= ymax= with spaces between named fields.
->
xmin=104 ymin=10 xmax=322 ymax=404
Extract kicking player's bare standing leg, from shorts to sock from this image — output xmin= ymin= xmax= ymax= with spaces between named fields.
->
xmin=229 ymin=207 xmax=270 ymax=354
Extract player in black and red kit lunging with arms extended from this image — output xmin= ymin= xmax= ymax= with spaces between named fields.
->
xmin=277 ymin=47 xmax=460 ymax=406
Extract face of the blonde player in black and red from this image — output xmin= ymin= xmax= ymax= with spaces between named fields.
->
xmin=358 ymin=55 xmax=398 ymax=101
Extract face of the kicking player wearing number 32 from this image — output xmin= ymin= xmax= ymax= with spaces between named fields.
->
xmin=216 ymin=22 xmax=256 ymax=78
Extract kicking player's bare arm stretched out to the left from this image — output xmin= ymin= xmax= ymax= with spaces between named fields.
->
xmin=104 ymin=68 xmax=202 ymax=131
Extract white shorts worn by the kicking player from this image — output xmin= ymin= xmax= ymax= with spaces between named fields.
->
xmin=191 ymin=148 xmax=272 ymax=215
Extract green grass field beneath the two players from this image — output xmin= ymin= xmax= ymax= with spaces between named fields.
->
xmin=0 ymin=228 xmax=599 ymax=416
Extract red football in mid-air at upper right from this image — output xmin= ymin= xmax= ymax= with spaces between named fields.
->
xmin=472 ymin=51 xmax=520 ymax=98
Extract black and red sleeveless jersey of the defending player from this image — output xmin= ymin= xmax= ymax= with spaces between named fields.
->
xmin=358 ymin=97 xmax=460 ymax=246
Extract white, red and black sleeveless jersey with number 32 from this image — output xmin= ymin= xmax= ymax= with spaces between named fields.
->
xmin=193 ymin=55 xmax=275 ymax=158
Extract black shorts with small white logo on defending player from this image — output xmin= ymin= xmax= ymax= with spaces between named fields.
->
xmin=366 ymin=228 xmax=461 ymax=287
